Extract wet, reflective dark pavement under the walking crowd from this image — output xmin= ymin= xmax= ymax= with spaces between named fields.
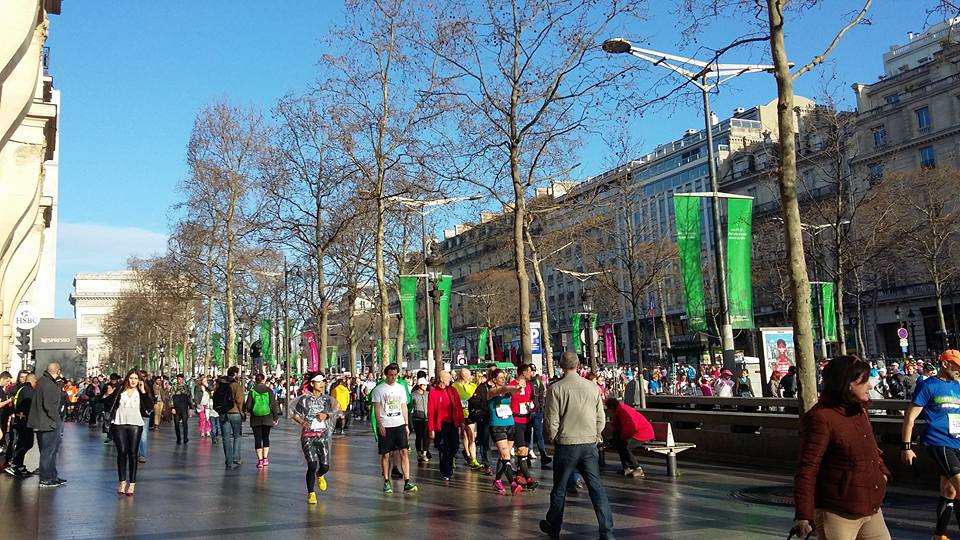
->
xmin=0 ymin=420 xmax=935 ymax=540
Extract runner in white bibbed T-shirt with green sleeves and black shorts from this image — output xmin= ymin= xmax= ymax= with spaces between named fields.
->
xmin=370 ymin=364 xmax=418 ymax=493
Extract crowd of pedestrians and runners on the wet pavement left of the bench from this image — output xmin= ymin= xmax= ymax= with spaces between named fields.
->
xmin=0 ymin=353 xmax=653 ymax=538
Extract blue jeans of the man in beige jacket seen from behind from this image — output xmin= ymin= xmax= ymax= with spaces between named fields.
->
xmin=547 ymin=443 xmax=613 ymax=539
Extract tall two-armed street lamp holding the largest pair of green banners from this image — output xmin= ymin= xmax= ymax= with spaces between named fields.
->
xmin=603 ymin=38 xmax=774 ymax=369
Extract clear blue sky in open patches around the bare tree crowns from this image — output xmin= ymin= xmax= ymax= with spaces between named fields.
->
xmin=47 ymin=0 xmax=932 ymax=317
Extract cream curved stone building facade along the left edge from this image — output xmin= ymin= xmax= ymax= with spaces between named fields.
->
xmin=0 ymin=0 xmax=60 ymax=369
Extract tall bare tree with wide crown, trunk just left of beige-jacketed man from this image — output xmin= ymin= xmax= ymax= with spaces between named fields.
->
xmin=433 ymin=0 xmax=640 ymax=368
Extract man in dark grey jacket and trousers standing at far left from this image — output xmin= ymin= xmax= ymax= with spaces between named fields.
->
xmin=27 ymin=362 xmax=67 ymax=487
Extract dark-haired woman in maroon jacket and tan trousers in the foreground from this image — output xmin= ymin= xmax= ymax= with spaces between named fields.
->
xmin=793 ymin=356 xmax=890 ymax=540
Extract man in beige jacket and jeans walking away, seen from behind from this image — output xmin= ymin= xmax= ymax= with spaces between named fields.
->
xmin=540 ymin=352 xmax=613 ymax=540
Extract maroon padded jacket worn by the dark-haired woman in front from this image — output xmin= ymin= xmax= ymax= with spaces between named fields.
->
xmin=793 ymin=402 xmax=890 ymax=522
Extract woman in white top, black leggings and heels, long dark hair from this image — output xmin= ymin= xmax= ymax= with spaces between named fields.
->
xmin=110 ymin=369 xmax=153 ymax=496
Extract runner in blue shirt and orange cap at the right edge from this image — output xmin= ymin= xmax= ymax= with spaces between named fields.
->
xmin=900 ymin=349 xmax=960 ymax=538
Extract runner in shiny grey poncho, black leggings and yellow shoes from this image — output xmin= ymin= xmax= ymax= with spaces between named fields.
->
xmin=293 ymin=373 xmax=340 ymax=504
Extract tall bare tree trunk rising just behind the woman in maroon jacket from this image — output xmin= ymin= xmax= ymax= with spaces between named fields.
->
xmin=767 ymin=0 xmax=817 ymax=415
